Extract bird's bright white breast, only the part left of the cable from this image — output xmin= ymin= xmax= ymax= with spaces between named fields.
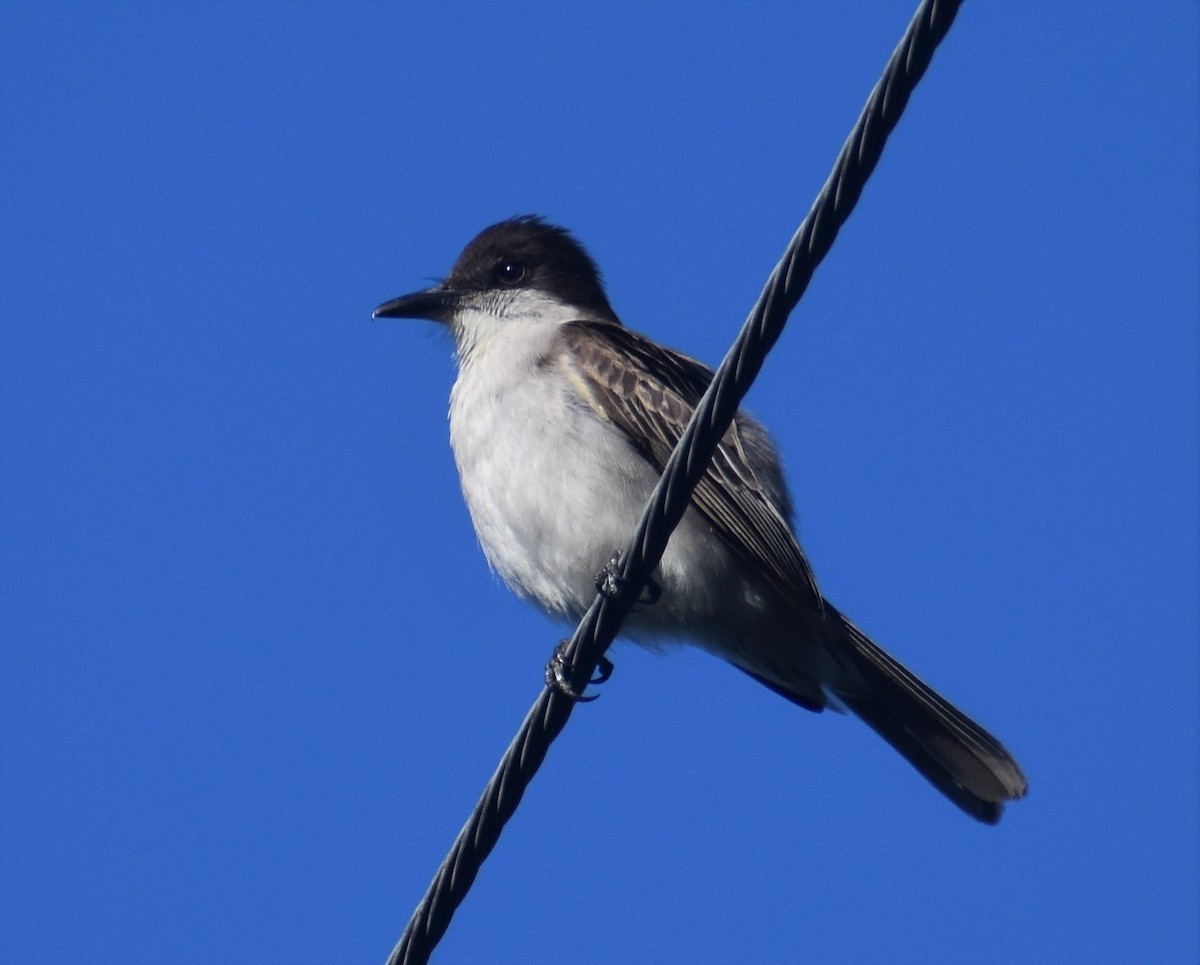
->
xmin=450 ymin=309 xmax=654 ymax=617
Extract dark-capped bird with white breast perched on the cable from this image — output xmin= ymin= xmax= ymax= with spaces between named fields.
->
xmin=373 ymin=215 xmax=1027 ymax=825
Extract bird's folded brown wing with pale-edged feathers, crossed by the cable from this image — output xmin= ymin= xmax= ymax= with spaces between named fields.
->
xmin=562 ymin=320 xmax=821 ymax=607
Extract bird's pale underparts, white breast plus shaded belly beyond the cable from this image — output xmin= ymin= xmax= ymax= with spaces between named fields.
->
xmin=450 ymin=304 xmax=782 ymax=652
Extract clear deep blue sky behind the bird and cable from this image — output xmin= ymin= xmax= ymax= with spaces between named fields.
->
xmin=0 ymin=2 xmax=1200 ymax=964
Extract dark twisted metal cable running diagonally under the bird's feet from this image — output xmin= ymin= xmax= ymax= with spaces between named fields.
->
xmin=388 ymin=0 xmax=962 ymax=965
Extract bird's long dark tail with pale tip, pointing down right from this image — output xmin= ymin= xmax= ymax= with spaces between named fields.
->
xmin=827 ymin=606 xmax=1028 ymax=825
